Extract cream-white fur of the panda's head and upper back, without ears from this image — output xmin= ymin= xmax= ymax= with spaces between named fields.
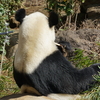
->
xmin=14 ymin=12 xmax=57 ymax=74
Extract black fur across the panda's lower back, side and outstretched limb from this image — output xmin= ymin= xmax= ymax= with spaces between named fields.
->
xmin=14 ymin=51 xmax=100 ymax=95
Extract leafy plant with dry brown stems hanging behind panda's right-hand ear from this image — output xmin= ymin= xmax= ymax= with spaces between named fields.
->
xmin=46 ymin=0 xmax=85 ymax=29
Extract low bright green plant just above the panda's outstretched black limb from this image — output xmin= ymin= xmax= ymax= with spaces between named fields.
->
xmin=70 ymin=49 xmax=100 ymax=68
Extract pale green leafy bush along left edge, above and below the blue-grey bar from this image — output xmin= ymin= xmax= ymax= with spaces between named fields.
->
xmin=0 ymin=0 xmax=23 ymax=74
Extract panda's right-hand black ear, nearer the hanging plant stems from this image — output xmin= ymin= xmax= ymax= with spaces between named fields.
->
xmin=48 ymin=11 xmax=59 ymax=28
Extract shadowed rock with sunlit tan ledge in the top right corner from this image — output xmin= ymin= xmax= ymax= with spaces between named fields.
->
xmin=81 ymin=0 xmax=100 ymax=20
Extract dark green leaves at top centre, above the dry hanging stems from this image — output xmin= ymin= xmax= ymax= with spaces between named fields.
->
xmin=46 ymin=0 xmax=85 ymax=16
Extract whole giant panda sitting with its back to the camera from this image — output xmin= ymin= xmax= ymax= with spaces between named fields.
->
xmin=13 ymin=9 xmax=100 ymax=96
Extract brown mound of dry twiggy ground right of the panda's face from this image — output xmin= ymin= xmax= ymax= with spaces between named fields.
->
xmin=56 ymin=29 xmax=100 ymax=54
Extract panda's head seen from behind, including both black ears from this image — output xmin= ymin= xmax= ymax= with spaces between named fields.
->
xmin=15 ymin=9 xmax=58 ymax=40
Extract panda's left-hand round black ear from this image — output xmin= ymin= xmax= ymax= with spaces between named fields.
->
xmin=15 ymin=9 xmax=26 ymax=24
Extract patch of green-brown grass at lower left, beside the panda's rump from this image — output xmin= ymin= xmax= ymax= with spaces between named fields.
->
xmin=0 ymin=60 xmax=19 ymax=97
